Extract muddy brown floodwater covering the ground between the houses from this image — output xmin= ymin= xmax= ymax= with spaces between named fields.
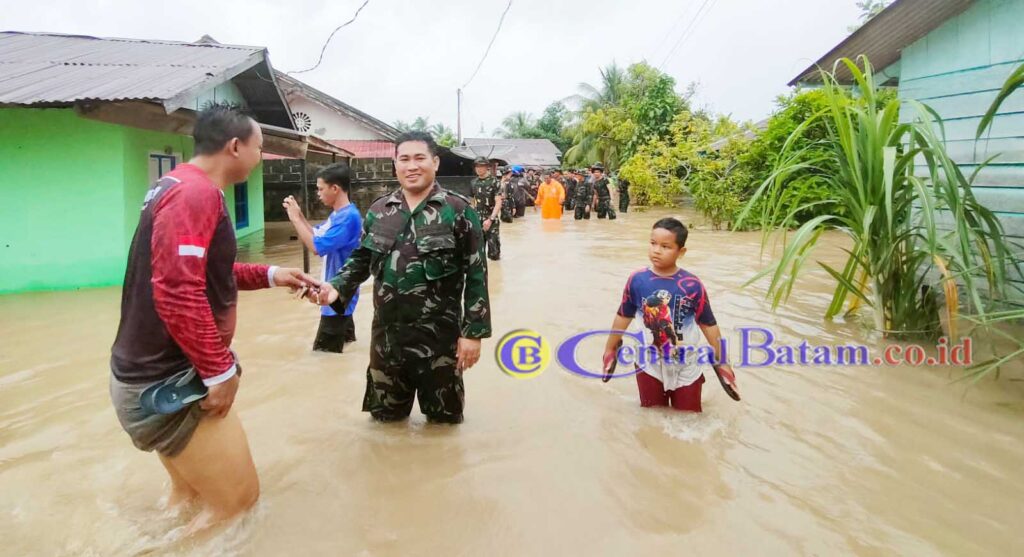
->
xmin=0 ymin=210 xmax=1024 ymax=556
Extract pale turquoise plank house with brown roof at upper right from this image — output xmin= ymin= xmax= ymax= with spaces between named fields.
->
xmin=790 ymin=0 xmax=1024 ymax=290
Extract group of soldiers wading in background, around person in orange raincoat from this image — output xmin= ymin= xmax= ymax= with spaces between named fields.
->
xmin=471 ymin=157 xmax=630 ymax=261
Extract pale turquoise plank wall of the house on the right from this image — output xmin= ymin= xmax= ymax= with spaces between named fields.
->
xmin=899 ymin=0 xmax=1024 ymax=294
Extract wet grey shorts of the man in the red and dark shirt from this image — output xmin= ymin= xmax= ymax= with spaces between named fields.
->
xmin=111 ymin=374 xmax=203 ymax=457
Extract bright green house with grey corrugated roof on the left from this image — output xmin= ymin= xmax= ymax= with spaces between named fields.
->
xmin=0 ymin=33 xmax=344 ymax=293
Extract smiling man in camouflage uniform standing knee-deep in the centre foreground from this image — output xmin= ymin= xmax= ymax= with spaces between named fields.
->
xmin=317 ymin=132 xmax=490 ymax=424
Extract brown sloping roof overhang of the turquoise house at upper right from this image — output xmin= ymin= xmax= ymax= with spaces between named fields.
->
xmin=790 ymin=0 xmax=974 ymax=85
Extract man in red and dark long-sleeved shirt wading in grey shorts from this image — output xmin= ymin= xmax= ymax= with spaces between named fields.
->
xmin=111 ymin=105 xmax=318 ymax=533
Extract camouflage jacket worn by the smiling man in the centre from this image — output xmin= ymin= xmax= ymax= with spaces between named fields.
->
xmin=331 ymin=182 xmax=490 ymax=350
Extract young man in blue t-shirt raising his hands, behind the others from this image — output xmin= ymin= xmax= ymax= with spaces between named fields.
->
xmin=284 ymin=163 xmax=362 ymax=353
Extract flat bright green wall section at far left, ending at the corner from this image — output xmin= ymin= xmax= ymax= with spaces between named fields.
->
xmin=0 ymin=109 xmax=125 ymax=293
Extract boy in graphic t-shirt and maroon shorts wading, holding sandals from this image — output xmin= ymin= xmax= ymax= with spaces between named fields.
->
xmin=604 ymin=218 xmax=739 ymax=412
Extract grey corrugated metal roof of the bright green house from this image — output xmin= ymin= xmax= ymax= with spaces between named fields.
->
xmin=0 ymin=32 xmax=269 ymax=104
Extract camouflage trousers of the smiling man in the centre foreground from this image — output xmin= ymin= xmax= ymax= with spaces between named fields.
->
xmin=362 ymin=335 xmax=466 ymax=424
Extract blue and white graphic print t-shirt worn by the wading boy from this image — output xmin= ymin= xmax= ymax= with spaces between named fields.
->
xmin=618 ymin=268 xmax=717 ymax=390
